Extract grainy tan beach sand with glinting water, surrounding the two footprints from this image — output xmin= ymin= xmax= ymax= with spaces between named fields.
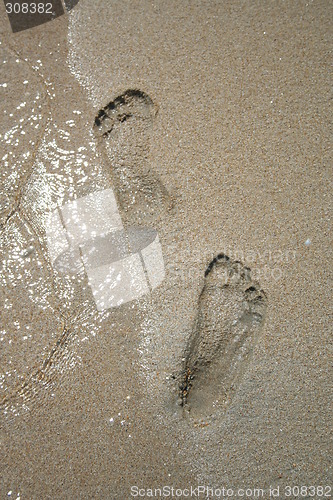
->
xmin=0 ymin=0 xmax=332 ymax=499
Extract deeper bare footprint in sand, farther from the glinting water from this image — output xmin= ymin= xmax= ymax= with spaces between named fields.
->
xmin=179 ymin=254 xmax=267 ymax=419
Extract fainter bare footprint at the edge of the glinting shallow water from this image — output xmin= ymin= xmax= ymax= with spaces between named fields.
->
xmin=94 ymin=90 xmax=172 ymax=224
